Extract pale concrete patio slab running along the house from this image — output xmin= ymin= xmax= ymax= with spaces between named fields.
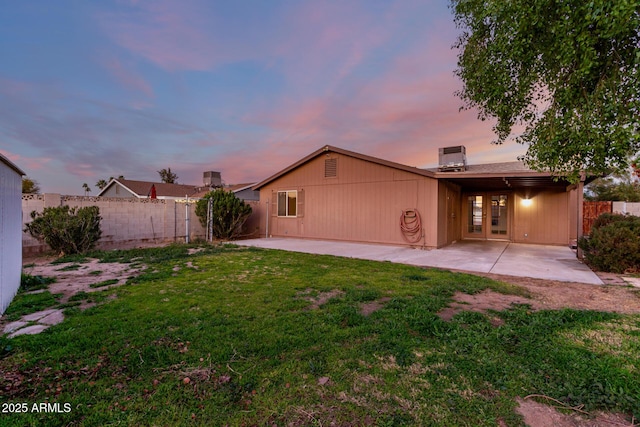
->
xmin=234 ymin=238 xmax=603 ymax=285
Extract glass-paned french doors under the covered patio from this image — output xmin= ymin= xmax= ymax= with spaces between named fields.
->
xmin=462 ymin=193 xmax=510 ymax=240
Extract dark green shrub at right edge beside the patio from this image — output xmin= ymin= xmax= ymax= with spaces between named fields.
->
xmin=578 ymin=214 xmax=640 ymax=273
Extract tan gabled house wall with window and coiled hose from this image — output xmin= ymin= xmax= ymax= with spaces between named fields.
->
xmin=255 ymin=152 xmax=438 ymax=247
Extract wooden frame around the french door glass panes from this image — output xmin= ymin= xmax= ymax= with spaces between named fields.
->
xmin=460 ymin=191 xmax=513 ymax=241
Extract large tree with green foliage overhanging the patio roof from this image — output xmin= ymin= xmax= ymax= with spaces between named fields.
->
xmin=451 ymin=0 xmax=640 ymax=182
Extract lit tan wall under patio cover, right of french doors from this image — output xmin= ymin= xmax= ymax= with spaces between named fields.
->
xmin=511 ymin=191 xmax=577 ymax=245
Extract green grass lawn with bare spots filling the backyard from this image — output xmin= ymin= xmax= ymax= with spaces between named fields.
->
xmin=0 ymin=246 xmax=640 ymax=426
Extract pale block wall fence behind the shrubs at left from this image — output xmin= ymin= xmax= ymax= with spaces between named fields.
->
xmin=22 ymin=193 xmax=259 ymax=256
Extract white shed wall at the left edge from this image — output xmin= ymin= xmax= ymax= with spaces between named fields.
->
xmin=0 ymin=154 xmax=24 ymax=314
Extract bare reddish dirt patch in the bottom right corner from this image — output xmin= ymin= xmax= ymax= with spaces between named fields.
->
xmin=516 ymin=399 xmax=638 ymax=427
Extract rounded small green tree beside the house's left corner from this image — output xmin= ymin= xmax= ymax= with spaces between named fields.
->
xmin=196 ymin=188 xmax=251 ymax=240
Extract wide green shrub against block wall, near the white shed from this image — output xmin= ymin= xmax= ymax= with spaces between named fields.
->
xmin=24 ymin=206 xmax=102 ymax=255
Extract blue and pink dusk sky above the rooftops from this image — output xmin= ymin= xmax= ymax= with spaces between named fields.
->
xmin=0 ymin=0 xmax=526 ymax=194
